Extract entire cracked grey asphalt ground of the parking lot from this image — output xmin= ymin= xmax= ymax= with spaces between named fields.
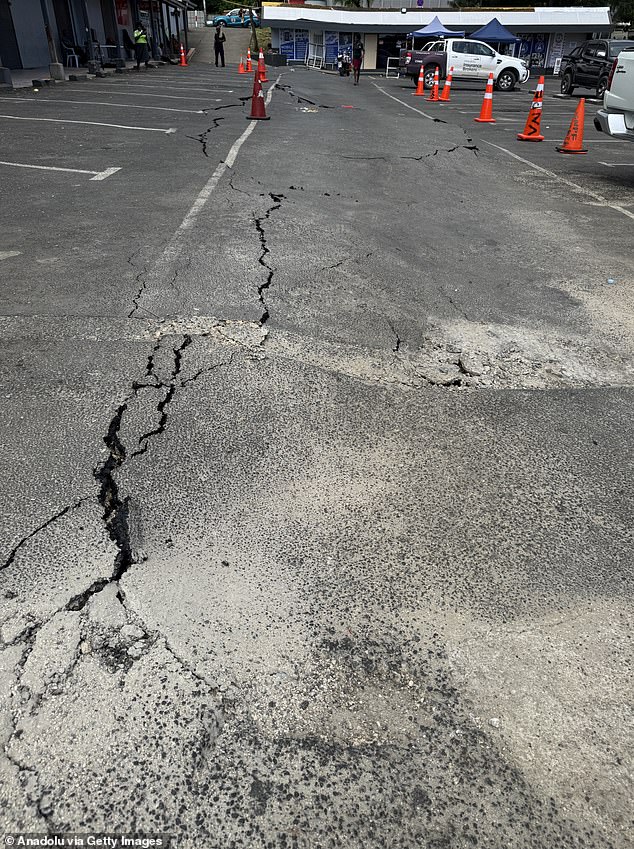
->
xmin=0 ymin=54 xmax=634 ymax=849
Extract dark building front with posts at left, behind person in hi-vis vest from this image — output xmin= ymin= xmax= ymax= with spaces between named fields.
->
xmin=0 ymin=0 xmax=194 ymax=76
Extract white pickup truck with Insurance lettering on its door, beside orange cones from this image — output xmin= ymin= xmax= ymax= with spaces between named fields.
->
xmin=399 ymin=38 xmax=530 ymax=91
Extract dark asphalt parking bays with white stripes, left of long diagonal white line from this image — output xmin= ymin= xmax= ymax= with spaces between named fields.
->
xmin=0 ymin=66 xmax=258 ymax=314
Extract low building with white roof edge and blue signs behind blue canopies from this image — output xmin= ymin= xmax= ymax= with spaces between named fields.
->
xmin=262 ymin=3 xmax=613 ymax=70
